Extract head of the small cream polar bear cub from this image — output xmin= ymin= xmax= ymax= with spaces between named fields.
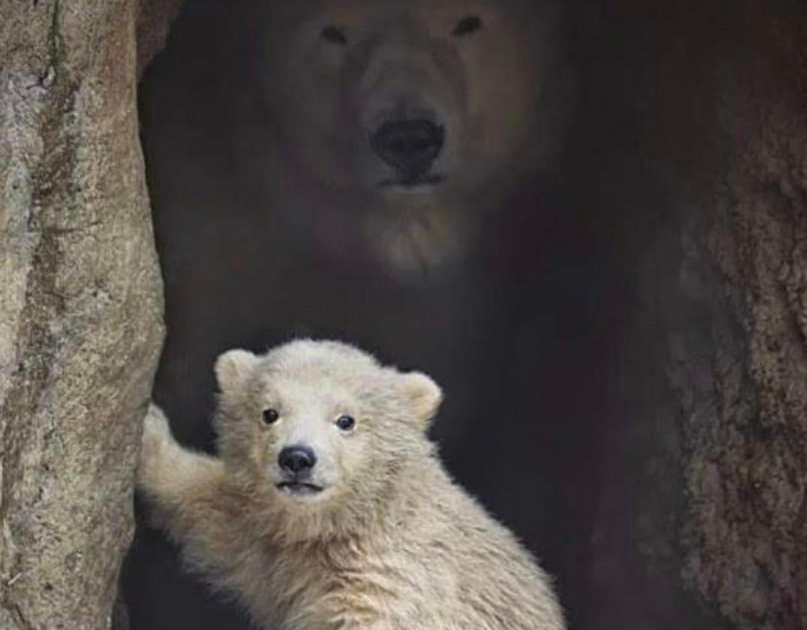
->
xmin=215 ymin=340 xmax=442 ymax=514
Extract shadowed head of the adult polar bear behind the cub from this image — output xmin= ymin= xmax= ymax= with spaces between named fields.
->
xmin=240 ymin=0 xmax=562 ymax=276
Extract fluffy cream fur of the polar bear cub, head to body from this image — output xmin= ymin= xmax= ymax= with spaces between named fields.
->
xmin=138 ymin=340 xmax=564 ymax=630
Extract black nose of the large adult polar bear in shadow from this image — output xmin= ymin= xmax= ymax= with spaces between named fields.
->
xmin=370 ymin=120 xmax=445 ymax=179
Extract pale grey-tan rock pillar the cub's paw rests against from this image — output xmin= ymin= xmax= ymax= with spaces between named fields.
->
xmin=0 ymin=0 xmax=162 ymax=630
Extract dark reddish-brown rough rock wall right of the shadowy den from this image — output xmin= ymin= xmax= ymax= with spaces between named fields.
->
xmin=594 ymin=0 xmax=807 ymax=630
